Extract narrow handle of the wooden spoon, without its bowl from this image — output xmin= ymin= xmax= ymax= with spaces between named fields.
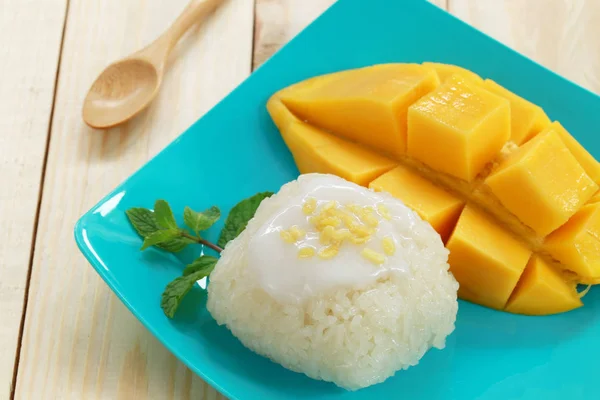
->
xmin=138 ymin=0 xmax=223 ymax=67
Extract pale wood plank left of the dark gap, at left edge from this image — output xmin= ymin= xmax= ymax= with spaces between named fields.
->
xmin=0 ymin=0 xmax=66 ymax=399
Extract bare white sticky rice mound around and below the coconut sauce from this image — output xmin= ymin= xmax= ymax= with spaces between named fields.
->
xmin=207 ymin=176 xmax=458 ymax=390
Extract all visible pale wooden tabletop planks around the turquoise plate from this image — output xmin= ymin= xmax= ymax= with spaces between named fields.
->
xmin=0 ymin=0 xmax=600 ymax=400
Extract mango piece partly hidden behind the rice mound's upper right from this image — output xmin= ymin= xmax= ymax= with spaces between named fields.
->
xmin=369 ymin=165 xmax=465 ymax=243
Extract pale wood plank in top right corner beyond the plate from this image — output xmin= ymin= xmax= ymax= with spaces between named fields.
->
xmin=449 ymin=0 xmax=600 ymax=93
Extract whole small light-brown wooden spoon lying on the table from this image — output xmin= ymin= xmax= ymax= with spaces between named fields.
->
xmin=83 ymin=0 xmax=222 ymax=128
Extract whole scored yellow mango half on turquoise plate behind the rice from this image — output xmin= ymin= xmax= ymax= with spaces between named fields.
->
xmin=267 ymin=63 xmax=600 ymax=315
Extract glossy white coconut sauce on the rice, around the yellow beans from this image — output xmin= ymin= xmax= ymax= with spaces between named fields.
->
xmin=248 ymin=175 xmax=419 ymax=303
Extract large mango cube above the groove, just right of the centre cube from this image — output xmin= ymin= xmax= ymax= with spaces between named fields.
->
xmin=486 ymin=130 xmax=598 ymax=236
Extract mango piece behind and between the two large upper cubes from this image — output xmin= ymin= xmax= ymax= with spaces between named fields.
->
xmin=483 ymin=79 xmax=550 ymax=145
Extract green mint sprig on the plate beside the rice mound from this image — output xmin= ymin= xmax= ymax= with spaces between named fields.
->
xmin=126 ymin=192 xmax=273 ymax=318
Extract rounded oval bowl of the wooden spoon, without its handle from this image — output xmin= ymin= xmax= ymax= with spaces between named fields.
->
xmin=83 ymin=58 xmax=162 ymax=128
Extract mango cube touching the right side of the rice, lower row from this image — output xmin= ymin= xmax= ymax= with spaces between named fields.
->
xmin=446 ymin=206 xmax=531 ymax=310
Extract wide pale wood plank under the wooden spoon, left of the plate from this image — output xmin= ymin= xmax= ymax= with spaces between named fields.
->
xmin=16 ymin=0 xmax=254 ymax=400
